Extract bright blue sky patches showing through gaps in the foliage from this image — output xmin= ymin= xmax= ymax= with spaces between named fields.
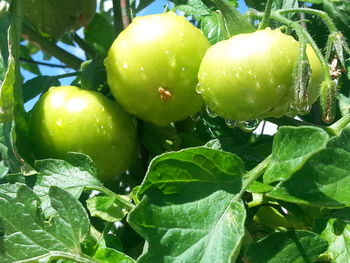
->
xmin=22 ymin=0 xmax=247 ymax=110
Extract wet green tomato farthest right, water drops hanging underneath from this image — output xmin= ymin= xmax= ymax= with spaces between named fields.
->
xmin=198 ymin=29 xmax=323 ymax=121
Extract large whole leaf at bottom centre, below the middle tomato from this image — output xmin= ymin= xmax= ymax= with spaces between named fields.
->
xmin=127 ymin=147 xmax=249 ymax=263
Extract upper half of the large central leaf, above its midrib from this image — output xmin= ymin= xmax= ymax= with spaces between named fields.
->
xmin=138 ymin=147 xmax=244 ymax=195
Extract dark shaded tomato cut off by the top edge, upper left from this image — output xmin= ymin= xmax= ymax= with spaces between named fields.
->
xmin=23 ymin=0 xmax=96 ymax=39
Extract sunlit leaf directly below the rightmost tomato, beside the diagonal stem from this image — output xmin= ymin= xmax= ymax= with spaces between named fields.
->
xmin=264 ymin=126 xmax=329 ymax=184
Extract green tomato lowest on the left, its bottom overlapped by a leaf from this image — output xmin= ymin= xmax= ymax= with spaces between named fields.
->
xmin=28 ymin=86 xmax=137 ymax=181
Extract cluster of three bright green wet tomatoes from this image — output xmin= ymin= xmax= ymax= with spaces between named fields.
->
xmin=29 ymin=12 xmax=322 ymax=181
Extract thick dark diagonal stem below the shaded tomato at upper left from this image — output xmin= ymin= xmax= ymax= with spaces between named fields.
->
xmin=22 ymin=23 xmax=83 ymax=70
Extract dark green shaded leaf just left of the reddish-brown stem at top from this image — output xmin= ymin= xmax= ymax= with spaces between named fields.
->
xmin=84 ymin=13 xmax=115 ymax=56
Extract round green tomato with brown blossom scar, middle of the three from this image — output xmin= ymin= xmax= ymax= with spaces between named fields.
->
xmin=105 ymin=12 xmax=210 ymax=126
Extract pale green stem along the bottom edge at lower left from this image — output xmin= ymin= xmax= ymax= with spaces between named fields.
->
xmin=16 ymin=251 xmax=99 ymax=263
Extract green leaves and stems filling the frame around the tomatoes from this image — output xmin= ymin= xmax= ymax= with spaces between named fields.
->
xmin=0 ymin=0 xmax=350 ymax=263
